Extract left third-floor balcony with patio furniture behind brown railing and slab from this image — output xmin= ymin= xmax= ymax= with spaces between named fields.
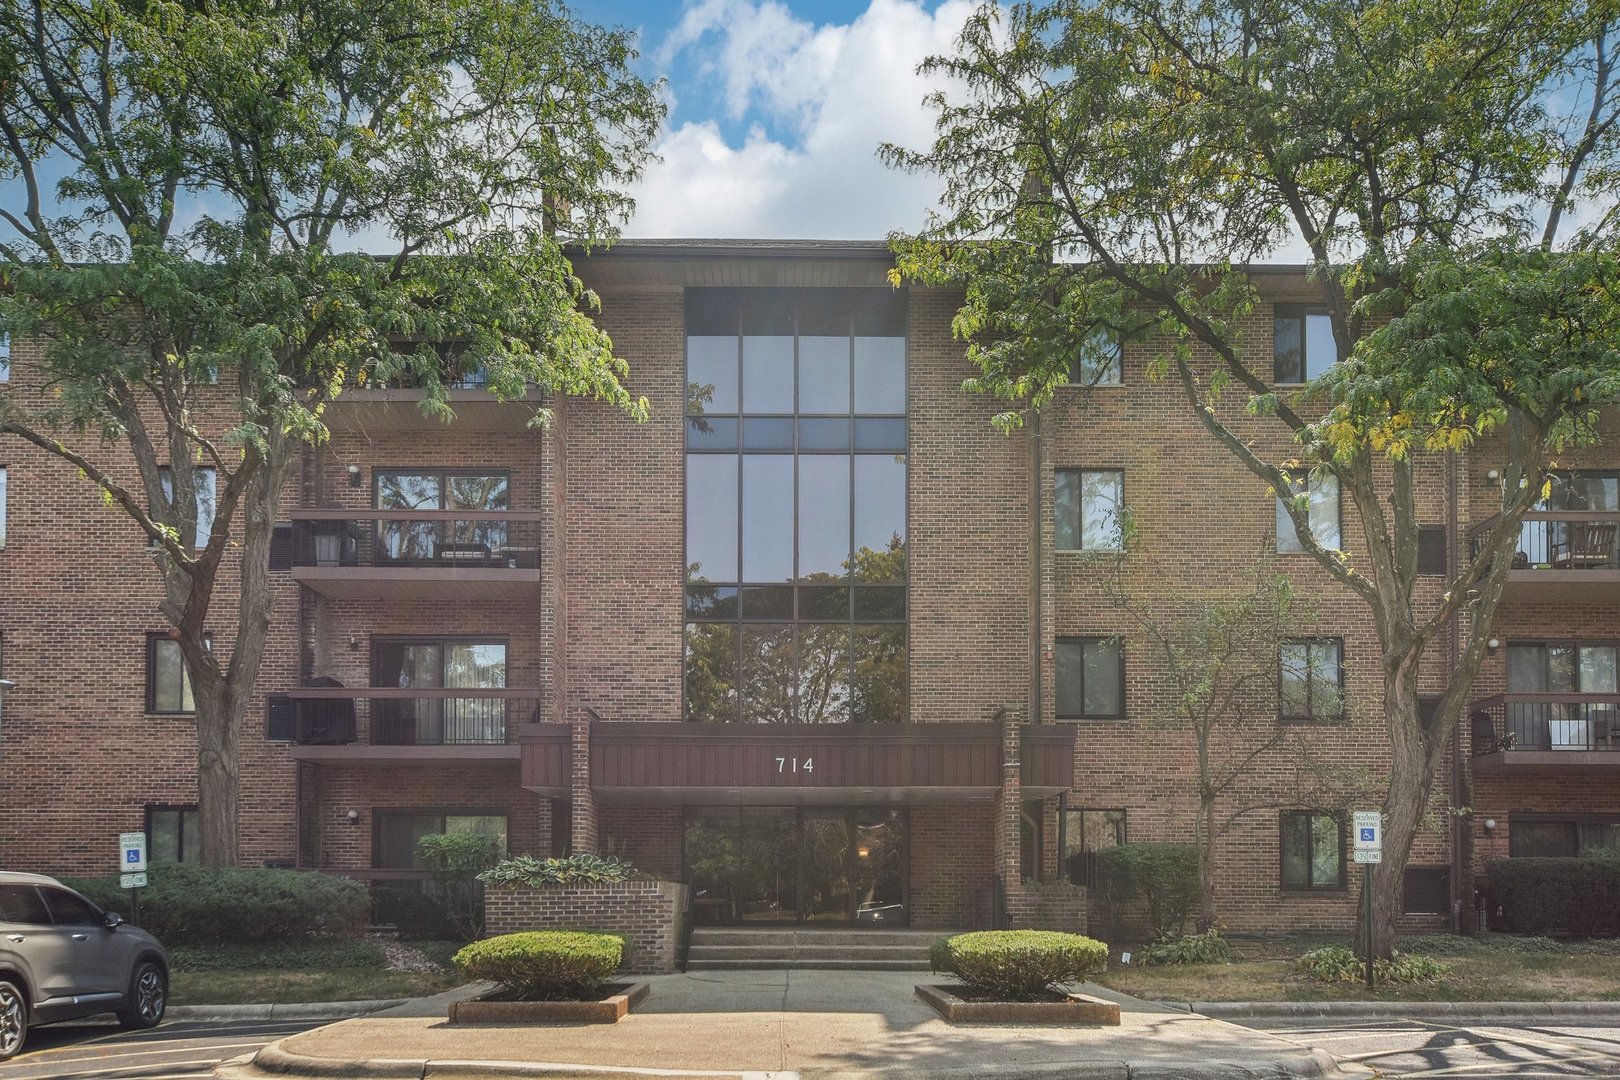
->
xmin=292 ymin=510 xmax=541 ymax=601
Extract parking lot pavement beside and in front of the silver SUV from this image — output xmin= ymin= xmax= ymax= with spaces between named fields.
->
xmin=0 ymin=1020 xmax=324 ymax=1080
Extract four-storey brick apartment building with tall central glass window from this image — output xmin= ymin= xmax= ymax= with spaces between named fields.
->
xmin=0 ymin=241 xmax=1620 ymax=929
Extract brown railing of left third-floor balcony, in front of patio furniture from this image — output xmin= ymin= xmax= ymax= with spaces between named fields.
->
xmin=292 ymin=510 xmax=541 ymax=570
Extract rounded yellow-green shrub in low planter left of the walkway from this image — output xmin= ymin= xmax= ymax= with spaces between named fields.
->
xmin=455 ymin=929 xmax=624 ymax=1001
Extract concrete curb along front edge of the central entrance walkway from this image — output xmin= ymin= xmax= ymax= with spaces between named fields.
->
xmin=239 ymin=1043 xmax=1341 ymax=1080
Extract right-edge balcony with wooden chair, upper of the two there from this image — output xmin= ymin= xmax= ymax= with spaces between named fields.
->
xmin=1471 ymin=510 xmax=1620 ymax=604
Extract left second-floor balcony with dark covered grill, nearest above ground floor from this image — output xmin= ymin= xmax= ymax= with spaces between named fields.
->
xmin=271 ymin=687 xmax=541 ymax=764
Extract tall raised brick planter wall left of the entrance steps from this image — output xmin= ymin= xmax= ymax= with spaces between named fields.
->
xmin=484 ymin=881 xmax=687 ymax=975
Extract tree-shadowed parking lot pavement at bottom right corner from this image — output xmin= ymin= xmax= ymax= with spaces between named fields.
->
xmin=1241 ymin=1017 xmax=1620 ymax=1080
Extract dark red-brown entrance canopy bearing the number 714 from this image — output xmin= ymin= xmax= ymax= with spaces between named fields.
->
xmin=518 ymin=721 xmax=1076 ymax=806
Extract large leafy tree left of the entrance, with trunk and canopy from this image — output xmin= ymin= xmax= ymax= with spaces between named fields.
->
xmin=0 ymin=0 xmax=663 ymax=865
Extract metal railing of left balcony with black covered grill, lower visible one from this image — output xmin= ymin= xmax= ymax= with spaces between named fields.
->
xmin=272 ymin=687 xmax=541 ymax=746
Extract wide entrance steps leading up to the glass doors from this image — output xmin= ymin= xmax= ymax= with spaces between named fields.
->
xmin=687 ymin=926 xmax=954 ymax=972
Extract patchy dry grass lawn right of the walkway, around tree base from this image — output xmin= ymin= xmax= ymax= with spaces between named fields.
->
xmin=1095 ymin=934 xmax=1620 ymax=1002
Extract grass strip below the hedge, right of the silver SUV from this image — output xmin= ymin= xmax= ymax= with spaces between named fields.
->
xmin=168 ymin=941 xmax=467 ymax=1006
